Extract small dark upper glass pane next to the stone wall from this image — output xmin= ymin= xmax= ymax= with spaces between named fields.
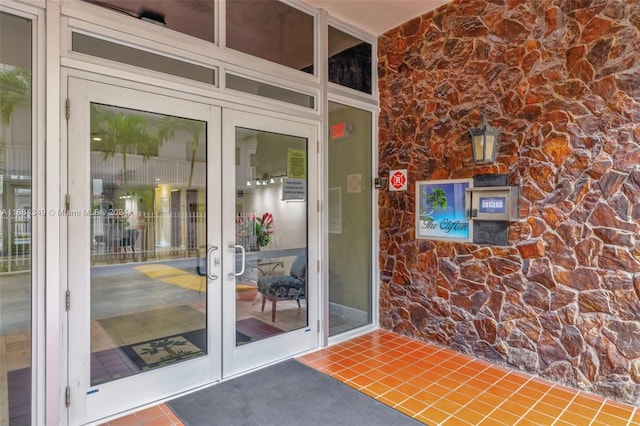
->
xmin=329 ymin=26 xmax=371 ymax=93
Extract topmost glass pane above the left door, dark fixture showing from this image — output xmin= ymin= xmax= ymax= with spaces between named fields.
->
xmin=84 ymin=0 xmax=215 ymax=43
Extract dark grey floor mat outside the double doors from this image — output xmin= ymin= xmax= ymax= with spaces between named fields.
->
xmin=168 ymin=360 xmax=420 ymax=426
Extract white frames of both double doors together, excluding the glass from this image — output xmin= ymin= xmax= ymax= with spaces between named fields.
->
xmin=60 ymin=73 xmax=322 ymax=424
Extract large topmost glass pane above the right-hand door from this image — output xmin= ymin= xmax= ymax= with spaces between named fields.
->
xmin=227 ymin=0 xmax=314 ymax=74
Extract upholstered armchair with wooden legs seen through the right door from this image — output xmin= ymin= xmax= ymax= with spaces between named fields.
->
xmin=258 ymin=255 xmax=307 ymax=322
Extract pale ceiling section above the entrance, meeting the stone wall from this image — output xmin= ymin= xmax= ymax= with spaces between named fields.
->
xmin=302 ymin=0 xmax=449 ymax=36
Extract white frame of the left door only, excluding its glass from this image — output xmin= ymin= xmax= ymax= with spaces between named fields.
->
xmin=65 ymin=77 xmax=222 ymax=424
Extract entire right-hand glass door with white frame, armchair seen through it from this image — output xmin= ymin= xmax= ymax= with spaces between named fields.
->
xmin=222 ymin=109 xmax=319 ymax=376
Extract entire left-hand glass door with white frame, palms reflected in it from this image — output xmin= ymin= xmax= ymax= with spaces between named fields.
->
xmin=64 ymin=78 xmax=222 ymax=424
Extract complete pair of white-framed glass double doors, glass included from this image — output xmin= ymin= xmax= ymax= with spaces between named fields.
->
xmin=60 ymin=78 xmax=319 ymax=424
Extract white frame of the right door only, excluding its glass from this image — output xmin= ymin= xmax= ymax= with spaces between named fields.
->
xmin=222 ymin=108 xmax=320 ymax=377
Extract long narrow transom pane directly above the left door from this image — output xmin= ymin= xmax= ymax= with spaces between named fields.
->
xmin=72 ymin=33 xmax=216 ymax=84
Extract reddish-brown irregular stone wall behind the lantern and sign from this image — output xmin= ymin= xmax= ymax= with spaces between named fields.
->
xmin=378 ymin=0 xmax=640 ymax=404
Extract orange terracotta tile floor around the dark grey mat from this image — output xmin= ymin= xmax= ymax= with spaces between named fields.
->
xmin=101 ymin=330 xmax=640 ymax=426
